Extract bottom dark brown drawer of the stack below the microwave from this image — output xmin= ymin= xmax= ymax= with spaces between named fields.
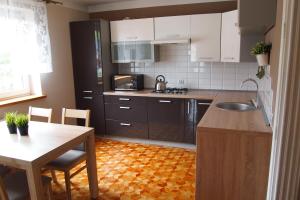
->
xmin=106 ymin=120 xmax=148 ymax=139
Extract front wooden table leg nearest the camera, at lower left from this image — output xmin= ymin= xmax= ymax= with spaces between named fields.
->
xmin=26 ymin=165 xmax=45 ymax=200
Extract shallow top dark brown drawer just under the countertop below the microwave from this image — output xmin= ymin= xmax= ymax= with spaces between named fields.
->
xmin=104 ymin=95 xmax=146 ymax=106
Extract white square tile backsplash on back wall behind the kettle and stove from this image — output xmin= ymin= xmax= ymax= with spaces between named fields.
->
xmin=119 ymin=44 xmax=257 ymax=90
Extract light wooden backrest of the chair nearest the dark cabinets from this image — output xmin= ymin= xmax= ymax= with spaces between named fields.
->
xmin=61 ymin=108 xmax=90 ymax=127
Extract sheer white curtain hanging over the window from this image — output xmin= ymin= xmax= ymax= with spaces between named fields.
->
xmin=0 ymin=0 xmax=52 ymax=74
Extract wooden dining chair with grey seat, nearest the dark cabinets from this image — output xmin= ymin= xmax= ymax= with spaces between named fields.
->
xmin=46 ymin=108 xmax=90 ymax=200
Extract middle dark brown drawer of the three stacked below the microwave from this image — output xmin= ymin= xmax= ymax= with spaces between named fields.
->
xmin=105 ymin=103 xmax=147 ymax=122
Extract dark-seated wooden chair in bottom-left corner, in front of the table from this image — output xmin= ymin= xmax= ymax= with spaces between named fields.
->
xmin=0 ymin=171 xmax=53 ymax=200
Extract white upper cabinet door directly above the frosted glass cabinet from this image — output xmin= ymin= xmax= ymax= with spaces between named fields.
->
xmin=110 ymin=18 xmax=154 ymax=42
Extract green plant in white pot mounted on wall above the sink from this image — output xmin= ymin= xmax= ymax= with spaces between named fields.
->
xmin=251 ymin=41 xmax=272 ymax=67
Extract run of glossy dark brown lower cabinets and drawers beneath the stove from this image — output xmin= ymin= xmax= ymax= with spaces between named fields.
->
xmin=104 ymin=95 xmax=211 ymax=144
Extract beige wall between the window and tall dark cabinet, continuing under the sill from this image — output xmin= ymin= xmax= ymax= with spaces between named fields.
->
xmin=0 ymin=4 xmax=88 ymax=122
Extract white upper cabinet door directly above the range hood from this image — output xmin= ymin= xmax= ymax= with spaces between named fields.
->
xmin=154 ymin=16 xmax=190 ymax=40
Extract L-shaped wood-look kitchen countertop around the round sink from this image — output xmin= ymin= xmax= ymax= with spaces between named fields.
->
xmin=104 ymin=89 xmax=272 ymax=134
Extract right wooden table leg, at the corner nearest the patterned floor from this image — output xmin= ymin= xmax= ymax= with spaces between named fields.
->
xmin=86 ymin=133 xmax=99 ymax=199
